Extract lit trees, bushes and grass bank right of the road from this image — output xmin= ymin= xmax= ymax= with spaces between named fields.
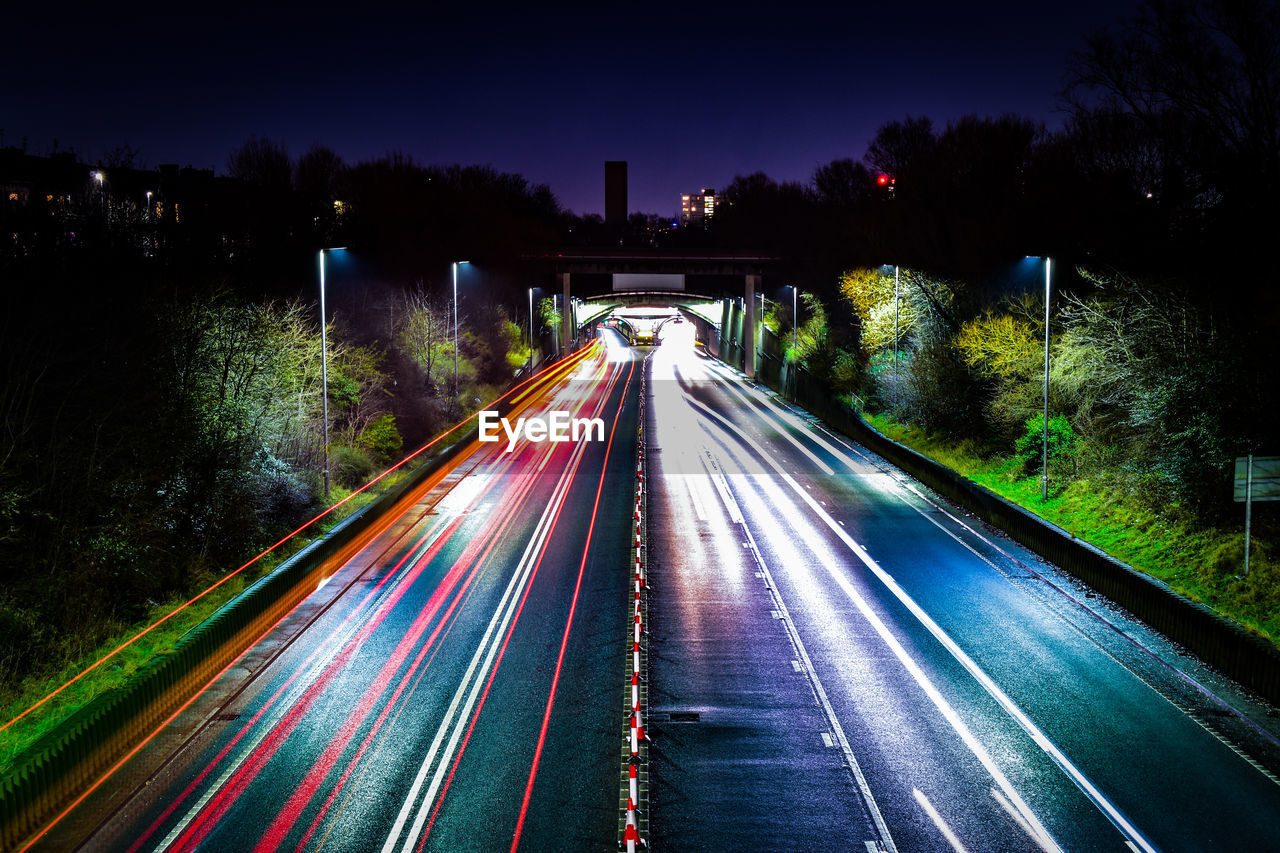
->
xmin=781 ymin=260 xmax=1280 ymax=640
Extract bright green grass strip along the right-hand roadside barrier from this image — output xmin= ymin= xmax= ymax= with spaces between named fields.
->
xmin=863 ymin=414 xmax=1280 ymax=643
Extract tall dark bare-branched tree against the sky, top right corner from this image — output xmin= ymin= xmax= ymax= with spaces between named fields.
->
xmin=1062 ymin=0 xmax=1280 ymax=263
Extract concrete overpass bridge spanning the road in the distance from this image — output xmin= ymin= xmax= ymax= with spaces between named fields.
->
xmin=530 ymin=248 xmax=777 ymax=377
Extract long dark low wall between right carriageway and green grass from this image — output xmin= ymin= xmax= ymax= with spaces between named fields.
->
xmin=739 ymin=335 xmax=1280 ymax=703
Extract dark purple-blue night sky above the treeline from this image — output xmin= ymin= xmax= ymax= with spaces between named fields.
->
xmin=0 ymin=0 xmax=1137 ymax=215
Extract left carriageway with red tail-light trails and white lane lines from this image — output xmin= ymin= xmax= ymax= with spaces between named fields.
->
xmin=36 ymin=336 xmax=640 ymax=853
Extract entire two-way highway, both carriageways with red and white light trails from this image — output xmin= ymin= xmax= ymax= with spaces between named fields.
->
xmin=22 ymin=323 xmax=1280 ymax=853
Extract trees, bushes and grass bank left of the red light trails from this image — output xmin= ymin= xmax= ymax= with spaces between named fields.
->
xmin=0 ymin=275 xmax=540 ymax=774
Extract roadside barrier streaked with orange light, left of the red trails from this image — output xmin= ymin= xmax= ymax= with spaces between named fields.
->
xmin=0 ymin=429 xmax=476 ymax=850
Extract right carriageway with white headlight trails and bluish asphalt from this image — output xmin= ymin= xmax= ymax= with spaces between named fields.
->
xmin=648 ymin=324 xmax=1280 ymax=853
